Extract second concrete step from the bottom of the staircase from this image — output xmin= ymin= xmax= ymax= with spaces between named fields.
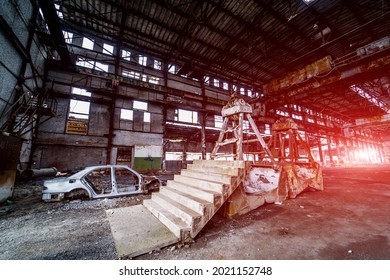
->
xmin=151 ymin=192 xmax=202 ymax=226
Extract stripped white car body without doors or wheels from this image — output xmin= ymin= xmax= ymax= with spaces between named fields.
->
xmin=42 ymin=165 xmax=161 ymax=201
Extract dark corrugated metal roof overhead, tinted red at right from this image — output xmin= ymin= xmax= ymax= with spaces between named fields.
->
xmin=56 ymin=0 xmax=390 ymax=122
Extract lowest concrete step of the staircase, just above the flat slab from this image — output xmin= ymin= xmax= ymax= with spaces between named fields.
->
xmin=143 ymin=199 xmax=191 ymax=239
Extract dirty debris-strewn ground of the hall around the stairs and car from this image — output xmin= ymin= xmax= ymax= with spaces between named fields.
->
xmin=0 ymin=166 xmax=390 ymax=260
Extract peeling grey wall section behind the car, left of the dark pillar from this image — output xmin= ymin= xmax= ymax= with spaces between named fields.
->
xmin=33 ymin=95 xmax=109 ymax=171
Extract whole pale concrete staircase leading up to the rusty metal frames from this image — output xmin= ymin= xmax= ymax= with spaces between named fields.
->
xmin=143 ymin=160 xmax=245 ymax=241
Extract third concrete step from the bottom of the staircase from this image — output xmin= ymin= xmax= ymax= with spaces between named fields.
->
xmin=160 ymin=186 xmax=214 ymax=216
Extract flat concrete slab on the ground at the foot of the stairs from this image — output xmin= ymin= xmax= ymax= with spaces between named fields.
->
xmin=106 ymin=205 xmax=179 ymax=258
